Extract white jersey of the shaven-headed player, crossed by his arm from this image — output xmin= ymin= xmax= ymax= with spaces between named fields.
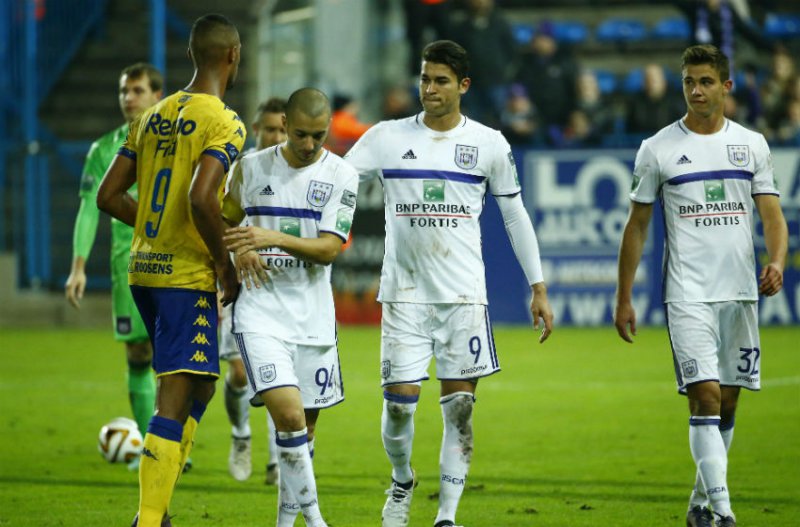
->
xmin=226 ymin=145 xmax=358 ymax=346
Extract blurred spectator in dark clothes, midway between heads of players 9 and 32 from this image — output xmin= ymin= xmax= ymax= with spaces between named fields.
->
xmin=517 ymin=21 xmax=577 ymax=137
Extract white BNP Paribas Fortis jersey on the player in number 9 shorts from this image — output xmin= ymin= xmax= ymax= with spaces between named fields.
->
xmin=345 ymin=114 xmax=520 ymax=304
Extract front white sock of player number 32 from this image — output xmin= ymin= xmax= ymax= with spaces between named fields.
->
xmin=689 ymin=415 xmax=733 ymax=516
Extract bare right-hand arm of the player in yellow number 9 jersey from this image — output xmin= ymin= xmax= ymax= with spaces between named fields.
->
xmin=189 ymin=154 xmax=239 ymax=306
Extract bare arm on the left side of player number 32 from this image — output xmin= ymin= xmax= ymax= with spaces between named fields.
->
xmin=614 ymin=201 xmax=653 ymax=342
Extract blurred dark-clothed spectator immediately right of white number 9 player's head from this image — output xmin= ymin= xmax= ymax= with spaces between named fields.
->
xmin=451 ymin=0 xmax=517 ymax=127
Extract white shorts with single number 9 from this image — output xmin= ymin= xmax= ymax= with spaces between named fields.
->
xmin=381 ymin=302 xmax=500 ymax=386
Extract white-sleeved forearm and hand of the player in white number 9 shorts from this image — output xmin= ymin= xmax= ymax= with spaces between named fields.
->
xmin=496 ymin=194 xmax=553 ymax=342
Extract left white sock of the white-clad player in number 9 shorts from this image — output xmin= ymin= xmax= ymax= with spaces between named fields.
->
xmin=381 ymin=392 xmax=419 ymax=483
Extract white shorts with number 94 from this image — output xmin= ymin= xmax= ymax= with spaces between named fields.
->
xmin=233 ymin=333 xmax=344 ymax=410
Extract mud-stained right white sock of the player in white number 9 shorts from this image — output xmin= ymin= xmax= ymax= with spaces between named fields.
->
xmin=434 ymin=392 xmax=475 ymax=523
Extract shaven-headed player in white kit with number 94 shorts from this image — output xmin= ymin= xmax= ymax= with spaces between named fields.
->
xmin=224 ymin=88 xmax=358 ymax=527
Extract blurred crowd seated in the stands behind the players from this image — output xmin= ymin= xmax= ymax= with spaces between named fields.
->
xmin=328 ymin=0 xmax=800 ymax=148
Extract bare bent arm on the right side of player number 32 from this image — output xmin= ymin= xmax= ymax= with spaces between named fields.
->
xmin=753 ymin=194 xmax=789 ymax=296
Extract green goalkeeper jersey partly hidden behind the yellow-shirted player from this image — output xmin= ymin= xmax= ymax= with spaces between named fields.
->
xmin=73 ymin=123 xmax=137 ymax=265
